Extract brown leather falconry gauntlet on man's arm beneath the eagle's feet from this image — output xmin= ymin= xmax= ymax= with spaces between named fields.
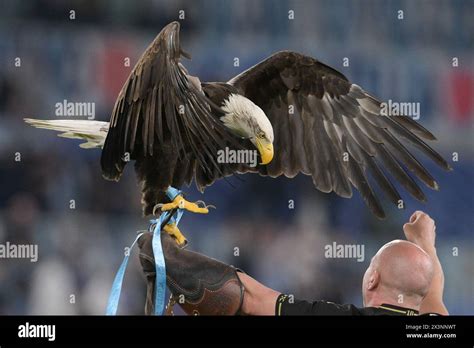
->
xmin=138 ymin=232 xmax=244 ymax=315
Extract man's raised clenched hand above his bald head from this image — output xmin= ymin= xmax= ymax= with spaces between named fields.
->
xmin=403 ymin=210 xmax=436 ymax=251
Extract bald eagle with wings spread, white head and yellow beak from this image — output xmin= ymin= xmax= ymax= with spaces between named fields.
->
xmin=26 ymin=22 xmax=451 ymax=237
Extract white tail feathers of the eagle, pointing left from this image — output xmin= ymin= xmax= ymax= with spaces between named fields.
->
xmin=24 ymin=118 xmax=109 ymax=149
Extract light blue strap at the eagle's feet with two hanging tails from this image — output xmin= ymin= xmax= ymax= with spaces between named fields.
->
xmin=106 ymin=186 xmax=184 ymax=315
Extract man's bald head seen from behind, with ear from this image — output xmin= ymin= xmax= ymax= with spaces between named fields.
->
xmin=362 ymin=240 xmax=433 ymax=308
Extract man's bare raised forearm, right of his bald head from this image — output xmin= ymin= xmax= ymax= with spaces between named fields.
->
xmin=420 ymin=247 xmax=449 ymax=315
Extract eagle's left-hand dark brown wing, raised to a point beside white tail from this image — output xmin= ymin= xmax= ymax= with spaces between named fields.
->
xmin=101 ymin=22 xmax=239 ymax=184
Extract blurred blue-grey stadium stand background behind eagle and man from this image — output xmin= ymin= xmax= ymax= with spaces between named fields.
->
xmin=0 ymin=0 xmax=474 ymax=314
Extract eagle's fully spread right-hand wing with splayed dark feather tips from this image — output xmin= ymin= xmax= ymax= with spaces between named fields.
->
xmin=229 ymin=51 xmax=451 ymax=218
